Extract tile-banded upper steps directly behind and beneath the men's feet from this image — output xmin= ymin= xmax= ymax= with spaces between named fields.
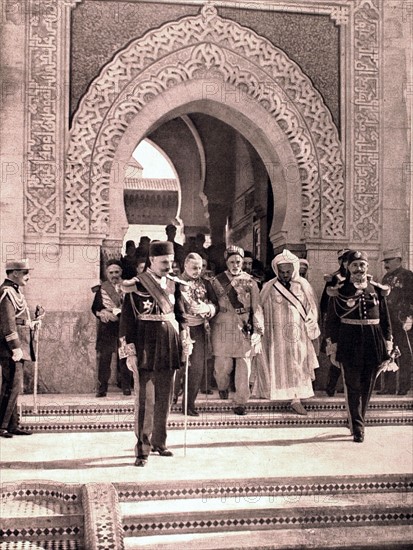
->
xmin=20 ymin=394 xmax=413 ymax=432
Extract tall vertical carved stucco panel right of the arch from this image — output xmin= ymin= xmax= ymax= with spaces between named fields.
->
xmin=352 ymin=0 xmax=381 ymax=242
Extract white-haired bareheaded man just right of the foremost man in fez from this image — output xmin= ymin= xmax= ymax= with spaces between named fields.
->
xmin=181 ymin=252 xmax=218 ymax=416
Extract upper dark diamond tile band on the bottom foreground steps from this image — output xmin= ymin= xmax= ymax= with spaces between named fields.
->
xmin=115 ymin=476 xmax=413 ymax=502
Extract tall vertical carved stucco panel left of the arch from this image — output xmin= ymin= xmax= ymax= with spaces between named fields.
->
xmin=25 ymin=0 xmax=58 ymax=235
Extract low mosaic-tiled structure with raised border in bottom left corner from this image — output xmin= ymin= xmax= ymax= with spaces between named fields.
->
xmin=0 ymin=481 xmax=124 ymax=550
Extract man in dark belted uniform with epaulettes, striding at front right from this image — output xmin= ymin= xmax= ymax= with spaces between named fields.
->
xmin=326 ymin=250 xmax=393 ymax=443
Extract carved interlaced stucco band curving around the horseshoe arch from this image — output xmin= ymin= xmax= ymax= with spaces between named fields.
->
xmin=64 ymin=2 xmax=345 ymax=238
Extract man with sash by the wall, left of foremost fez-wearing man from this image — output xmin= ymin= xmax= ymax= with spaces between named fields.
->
xmin=92 ymin=260 xmax=131 ymax=397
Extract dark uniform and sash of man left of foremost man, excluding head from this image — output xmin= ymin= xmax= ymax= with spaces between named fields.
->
xmin=92 ymin=281 xmax=132 ymax=396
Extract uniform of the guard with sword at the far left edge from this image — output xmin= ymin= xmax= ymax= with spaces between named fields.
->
xmin=0 ymin=279 xmax=35 ymax=433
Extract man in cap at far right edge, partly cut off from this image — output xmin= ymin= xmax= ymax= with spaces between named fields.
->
xmin=378 ymin=248 xmax=413 ymax=395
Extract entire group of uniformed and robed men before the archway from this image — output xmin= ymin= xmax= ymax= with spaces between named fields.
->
xmin=0 ymin=225 xmax=413 ymax=466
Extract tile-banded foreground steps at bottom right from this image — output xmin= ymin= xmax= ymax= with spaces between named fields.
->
xmin=116 ymin=476 xmax=413 ymax=550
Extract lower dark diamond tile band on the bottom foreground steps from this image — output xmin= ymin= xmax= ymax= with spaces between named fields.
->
xmin=123 ymin=511 xmax=413 ymax=536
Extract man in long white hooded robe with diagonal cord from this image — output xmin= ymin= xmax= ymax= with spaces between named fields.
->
xmin=256 ymin=250 xmax=320 ymax=415
